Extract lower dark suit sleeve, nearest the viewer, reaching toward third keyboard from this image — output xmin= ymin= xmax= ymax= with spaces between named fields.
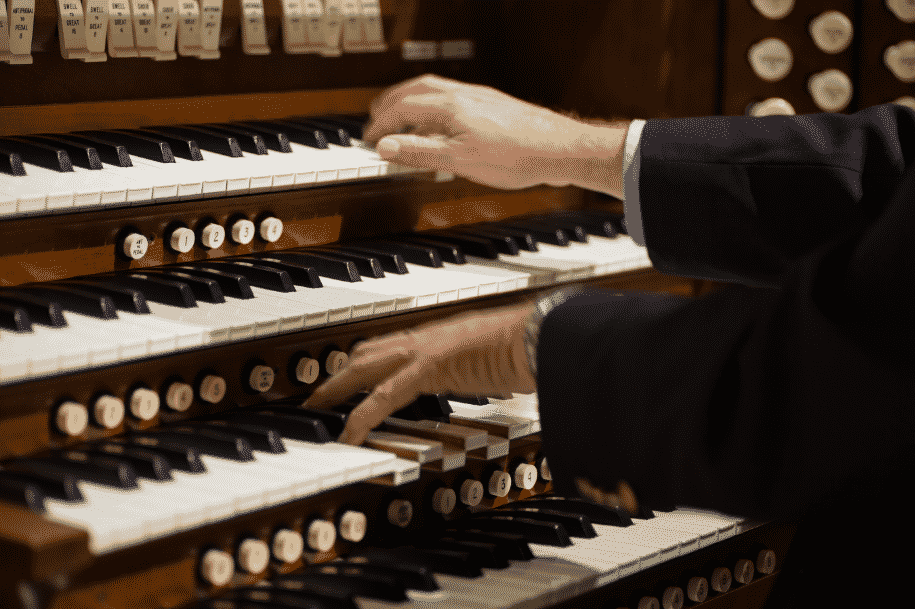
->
xmin=537 ymin=110 xmax=915 ymax=519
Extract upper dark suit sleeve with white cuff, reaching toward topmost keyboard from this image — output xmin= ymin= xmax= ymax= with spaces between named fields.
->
xmin=639 ymin=104 xmax=915 ymax=285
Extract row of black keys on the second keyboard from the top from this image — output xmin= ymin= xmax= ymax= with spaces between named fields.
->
xmin=0 ymin=210 xmax=625 ymax=332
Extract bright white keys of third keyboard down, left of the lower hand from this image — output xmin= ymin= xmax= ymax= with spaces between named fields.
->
xmin=46 ymin=439 xmax=395 ymax=554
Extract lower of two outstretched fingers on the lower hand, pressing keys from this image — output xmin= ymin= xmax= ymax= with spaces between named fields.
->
xmin=340 ymin=362 xmax=423 ymax=446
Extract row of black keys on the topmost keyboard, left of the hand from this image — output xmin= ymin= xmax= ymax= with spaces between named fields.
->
xmin=0 ymin=116 xmax=363 ymax=176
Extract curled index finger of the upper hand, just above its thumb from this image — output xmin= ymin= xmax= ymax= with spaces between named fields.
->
xmin=362 ymin=93 xmax=452 ymax=145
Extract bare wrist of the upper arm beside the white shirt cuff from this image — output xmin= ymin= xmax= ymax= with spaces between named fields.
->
xmin=564 ymin=121 xmax=629 ymax=199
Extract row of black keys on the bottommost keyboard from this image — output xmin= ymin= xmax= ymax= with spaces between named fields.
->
xmin=198 ymin=495 xmax=632 ymax=609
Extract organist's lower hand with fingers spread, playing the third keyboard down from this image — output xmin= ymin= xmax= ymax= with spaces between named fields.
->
xmin=305 ymin=304 xmax=537 ymax=445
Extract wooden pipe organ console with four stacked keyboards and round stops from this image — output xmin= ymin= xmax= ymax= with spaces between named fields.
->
xmin=0 ymin=0 xmax=915 ymax=609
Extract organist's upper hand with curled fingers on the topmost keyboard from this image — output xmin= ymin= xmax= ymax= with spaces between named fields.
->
xmin=364 ymin=75 xmax=622 ymax=190
